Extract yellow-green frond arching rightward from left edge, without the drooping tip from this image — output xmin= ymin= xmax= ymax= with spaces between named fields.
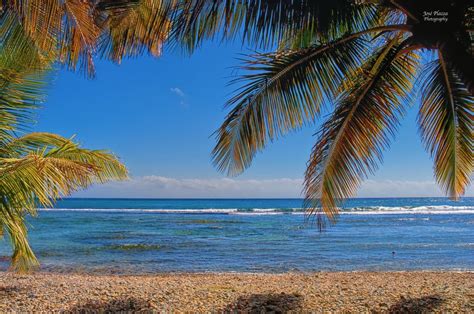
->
xmin=0 ymin=133 xmax=127 ymax=202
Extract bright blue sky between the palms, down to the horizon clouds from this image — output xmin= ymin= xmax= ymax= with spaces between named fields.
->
xmin=34 ymin=43 xmax=474 ymax=197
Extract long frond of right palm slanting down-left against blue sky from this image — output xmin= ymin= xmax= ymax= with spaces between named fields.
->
xmin=212 ymin=37 xmax=365 ymax=175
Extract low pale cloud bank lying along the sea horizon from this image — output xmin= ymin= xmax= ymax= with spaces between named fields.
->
xmin=73 ymin=175 xmax=474 ymax=198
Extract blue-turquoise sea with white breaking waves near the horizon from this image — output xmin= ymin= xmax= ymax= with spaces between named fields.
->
xmin=0 ymin=198 xmax=474 ymax=273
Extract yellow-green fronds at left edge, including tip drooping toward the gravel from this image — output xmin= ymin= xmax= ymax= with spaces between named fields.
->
xmin=0 ymin=133 xmax=127 ymax=270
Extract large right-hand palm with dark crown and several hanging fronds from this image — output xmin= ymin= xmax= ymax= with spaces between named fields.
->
xmin=172 ymin=0 xmax=474 ymax=226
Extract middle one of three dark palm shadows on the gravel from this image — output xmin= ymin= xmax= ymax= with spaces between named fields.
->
xmin=219 ymin=293 xmax=303 ymax=314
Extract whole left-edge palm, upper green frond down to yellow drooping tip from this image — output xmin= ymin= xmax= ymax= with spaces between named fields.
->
xmin=0 ymin=5 xmax=127 ymax=270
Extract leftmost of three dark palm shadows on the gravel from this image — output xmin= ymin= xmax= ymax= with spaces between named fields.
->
xmin=62 ymin=298 xmax=156 ymax=314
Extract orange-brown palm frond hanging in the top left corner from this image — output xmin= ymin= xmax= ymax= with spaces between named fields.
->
xmin=4 ymin=0 xmax=99 ymax=75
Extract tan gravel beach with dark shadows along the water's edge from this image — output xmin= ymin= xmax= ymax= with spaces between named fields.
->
xmin=0 ymin=272 xmax=474 ymax=313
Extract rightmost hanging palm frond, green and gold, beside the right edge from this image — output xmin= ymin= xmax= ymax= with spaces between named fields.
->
xmin=418 ymin=52 xmax=474 ymax=199
